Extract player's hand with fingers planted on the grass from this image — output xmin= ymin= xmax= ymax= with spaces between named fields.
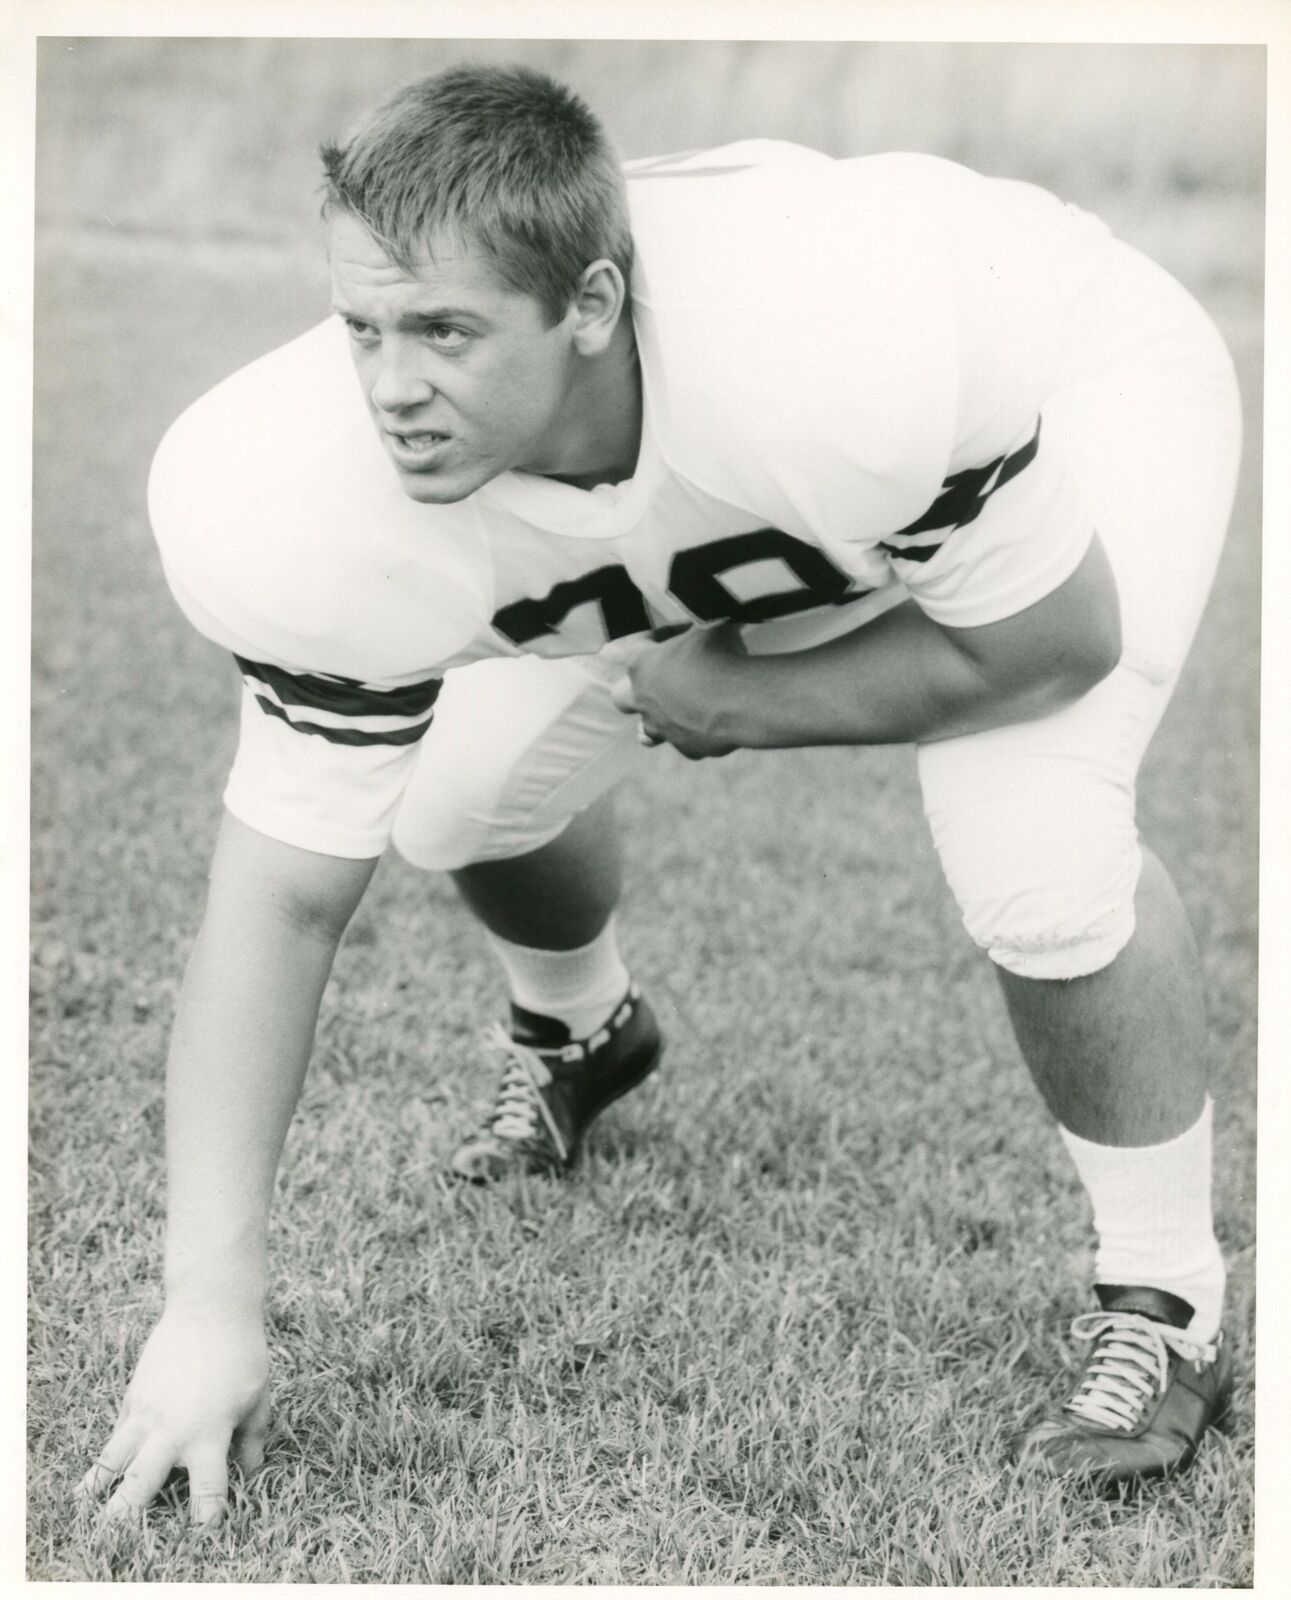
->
xmin=80 ymin=1306 xmax=269 ymax=1525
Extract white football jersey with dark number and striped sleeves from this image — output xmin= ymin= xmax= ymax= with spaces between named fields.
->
xmin=149 ymin=141 xmax=1109 ymax=856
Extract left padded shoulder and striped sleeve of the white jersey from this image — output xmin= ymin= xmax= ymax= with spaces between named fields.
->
xmin=149 ymin=316 xmax=493 ymax=859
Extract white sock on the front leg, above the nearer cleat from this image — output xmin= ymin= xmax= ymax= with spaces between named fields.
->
xmin=1059 ymin=1096 xmax=1224 ymax=1344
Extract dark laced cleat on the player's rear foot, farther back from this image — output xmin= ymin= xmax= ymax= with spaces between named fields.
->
xmin=450 ymin=984 xmax=664 ymax=1184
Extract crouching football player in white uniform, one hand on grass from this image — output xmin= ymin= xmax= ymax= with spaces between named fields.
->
xmin=85 ymin=69 xmax=1240 ymax=1520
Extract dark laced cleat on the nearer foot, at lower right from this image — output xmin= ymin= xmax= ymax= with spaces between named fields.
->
xmin=1013 ymin=1283 xmax=1233 ymax=1488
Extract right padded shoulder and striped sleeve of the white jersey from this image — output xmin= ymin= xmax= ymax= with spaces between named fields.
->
xmin=638 ymin=154 xmax=1105 ymax=627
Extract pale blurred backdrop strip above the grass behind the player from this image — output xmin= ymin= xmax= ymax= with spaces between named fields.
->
xmin=38 ymin=38 xmax=1264 ymax=302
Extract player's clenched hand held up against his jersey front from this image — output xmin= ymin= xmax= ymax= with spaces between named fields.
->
xmin=611 ymin=622 xmax=747 ymax=762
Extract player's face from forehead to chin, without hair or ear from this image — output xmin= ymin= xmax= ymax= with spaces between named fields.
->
xmin=328 ymin=211 xmax=576 ymax=504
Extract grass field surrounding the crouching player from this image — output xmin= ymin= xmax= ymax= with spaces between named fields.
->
xmin=27 ymin=37 xmax=1261 ymax=1587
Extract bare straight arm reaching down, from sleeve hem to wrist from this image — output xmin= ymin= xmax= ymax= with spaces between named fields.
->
xmin=166 ymin=824 xmax=370 ymax=1302
